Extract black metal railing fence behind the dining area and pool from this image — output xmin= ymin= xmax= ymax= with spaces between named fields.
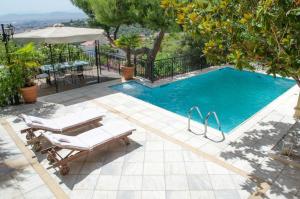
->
xmin=42 ymin=49 xmax=210 ymax=88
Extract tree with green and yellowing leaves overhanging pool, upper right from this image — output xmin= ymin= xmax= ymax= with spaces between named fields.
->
xmin=161 ymin=0 xmax=300 ymax=117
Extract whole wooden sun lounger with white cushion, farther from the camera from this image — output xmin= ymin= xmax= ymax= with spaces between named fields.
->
xmin=19 ymin=109 xmax=104 ymax=151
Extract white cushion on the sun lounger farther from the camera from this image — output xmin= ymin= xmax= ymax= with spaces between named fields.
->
xmin=20 ymin=109 xmax=104 ymax=132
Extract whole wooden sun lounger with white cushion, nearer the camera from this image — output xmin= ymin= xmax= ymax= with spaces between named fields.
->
xmin=42 ymin=119 xmax=135 ymax=175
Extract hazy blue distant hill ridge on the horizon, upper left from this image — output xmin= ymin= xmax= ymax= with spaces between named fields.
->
xmin=0 ymin=12 xmax=87 ymax=24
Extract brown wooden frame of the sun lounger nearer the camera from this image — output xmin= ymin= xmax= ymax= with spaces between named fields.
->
xmin=41 ymin=130 xmax=134 ymax=176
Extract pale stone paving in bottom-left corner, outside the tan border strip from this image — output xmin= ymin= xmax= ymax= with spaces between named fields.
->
xmin=0 ymin=125 xmax=54 ymax=199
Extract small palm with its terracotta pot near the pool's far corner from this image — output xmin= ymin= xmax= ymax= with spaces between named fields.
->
xmin=115 ymin=34 xmax=141 ymax=80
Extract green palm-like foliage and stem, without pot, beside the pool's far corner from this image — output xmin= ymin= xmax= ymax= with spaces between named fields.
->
xmin=115 ymin=34 xmax=141 ymax=67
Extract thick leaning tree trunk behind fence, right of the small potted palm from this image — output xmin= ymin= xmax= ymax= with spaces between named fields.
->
xmin=146 ymin=30 xmax=165 ymax=80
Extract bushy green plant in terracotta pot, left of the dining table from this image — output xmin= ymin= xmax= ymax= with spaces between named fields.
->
xmin=10 ymin=43 xmax=42 ymax=103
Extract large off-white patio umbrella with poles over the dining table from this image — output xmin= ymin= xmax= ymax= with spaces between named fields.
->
xmin=14 ymin=24 xmax=105 ymax=91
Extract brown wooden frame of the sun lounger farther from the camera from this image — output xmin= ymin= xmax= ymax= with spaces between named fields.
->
xmin=21 ymin=117 xmax=103 ymax=152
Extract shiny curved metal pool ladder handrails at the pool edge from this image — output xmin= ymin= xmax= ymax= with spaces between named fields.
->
xmin=188 ymin=106 xmax=225 ymax=140
